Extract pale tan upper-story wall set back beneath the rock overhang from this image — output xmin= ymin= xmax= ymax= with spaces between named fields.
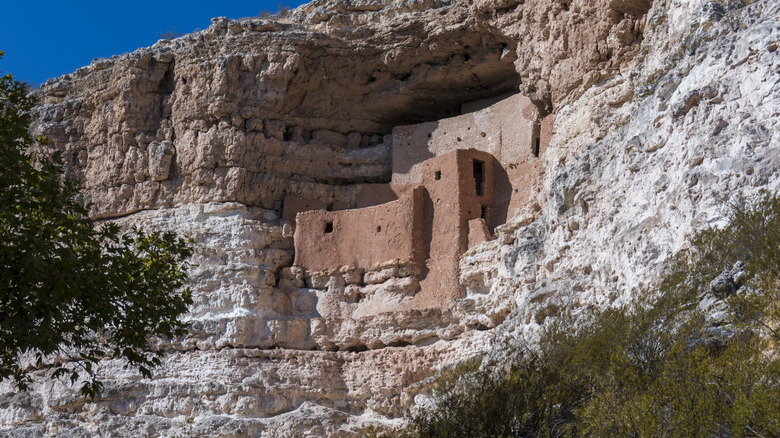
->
xmin=391 ymin=90 xmax=553 ymax=230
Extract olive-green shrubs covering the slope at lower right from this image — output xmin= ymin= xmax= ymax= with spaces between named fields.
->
xmin=409 ymin=195 xmax=780 ymax=437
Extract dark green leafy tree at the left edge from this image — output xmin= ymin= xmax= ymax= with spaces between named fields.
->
xmin=0 ymin=52 xmax=192 ymax=397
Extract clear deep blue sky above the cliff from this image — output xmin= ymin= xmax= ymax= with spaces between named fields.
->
xmin=0 ymin=0 xmax=305 ymax=85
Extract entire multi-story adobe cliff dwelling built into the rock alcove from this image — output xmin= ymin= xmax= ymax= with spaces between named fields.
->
xmin=280 ymin=94 xmax=552 ymax=313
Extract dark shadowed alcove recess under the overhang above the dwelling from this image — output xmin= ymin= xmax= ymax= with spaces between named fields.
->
xmin=283 ymin=28 xmax=521 ymax=135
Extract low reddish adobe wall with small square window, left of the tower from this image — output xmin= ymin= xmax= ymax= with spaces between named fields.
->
xmin=294 ymin=189 xmax=424 ymax=271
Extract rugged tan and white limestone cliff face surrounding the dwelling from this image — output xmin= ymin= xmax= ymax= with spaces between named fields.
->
xmin=0 ymin=0 xmax=780 ymax=437
